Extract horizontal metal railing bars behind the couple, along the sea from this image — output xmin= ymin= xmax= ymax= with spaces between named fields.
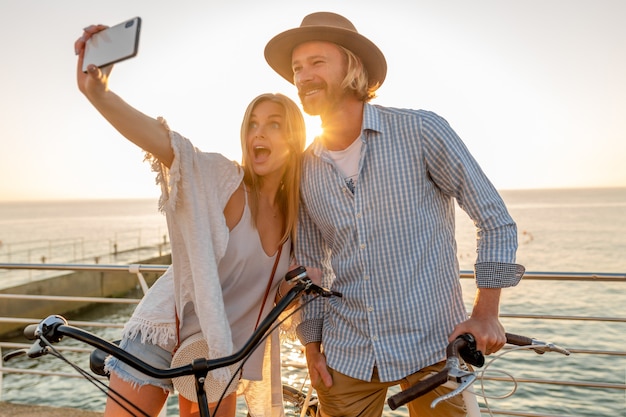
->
xmin=0 ymin=263 xmax=626 ymax=417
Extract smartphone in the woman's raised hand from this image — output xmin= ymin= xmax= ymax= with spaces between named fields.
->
xmin=83 ymin=17 xmax=141 ymax=72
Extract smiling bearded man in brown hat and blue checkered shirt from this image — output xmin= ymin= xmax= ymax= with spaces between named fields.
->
xmin=265 ymin=12 xmax=524 ymax=416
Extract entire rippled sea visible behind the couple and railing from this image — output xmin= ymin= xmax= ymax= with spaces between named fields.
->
xmin=0 ymin=188 xmax=626 ymax=417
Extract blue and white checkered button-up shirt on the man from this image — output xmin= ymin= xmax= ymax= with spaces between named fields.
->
xmin=296 ymin=104 xmax=523 ymax=381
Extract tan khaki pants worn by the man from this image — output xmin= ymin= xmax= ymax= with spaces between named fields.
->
xmin=314 ymin=362 xmax=466 ymax=417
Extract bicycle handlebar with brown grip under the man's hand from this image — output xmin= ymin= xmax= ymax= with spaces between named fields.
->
xmin=387 ymin=333 xmax=570 ymax=410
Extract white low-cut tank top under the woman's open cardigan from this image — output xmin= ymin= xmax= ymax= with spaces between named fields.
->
xmin=180 ymin=191 xmax=291 ymax=381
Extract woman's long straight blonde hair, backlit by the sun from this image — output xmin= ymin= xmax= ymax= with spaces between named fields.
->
xmin=241 ymin=93 xmax=306 ymax=245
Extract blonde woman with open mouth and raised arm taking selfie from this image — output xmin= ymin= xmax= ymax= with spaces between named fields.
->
xmin=75 ymin=25 xmax=305 ymax=416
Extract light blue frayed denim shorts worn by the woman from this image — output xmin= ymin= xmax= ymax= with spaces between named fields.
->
xmin=105 ymin=334 xmax=174 ymax=393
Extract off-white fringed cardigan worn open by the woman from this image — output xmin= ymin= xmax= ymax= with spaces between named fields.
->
xmin=123 ymin=127 xmax=284 ymax=417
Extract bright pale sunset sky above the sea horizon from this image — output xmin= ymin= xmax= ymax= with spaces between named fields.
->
xmin=0 ymin=0 xmax=626 ymax=202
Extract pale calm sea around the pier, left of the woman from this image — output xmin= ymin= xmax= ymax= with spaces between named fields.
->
xmin=0 ymin=199 xmax=169 ymax=288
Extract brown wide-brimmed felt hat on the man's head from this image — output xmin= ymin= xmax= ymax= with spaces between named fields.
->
xmin=265 ymin=12 xmax=387 ymax=86
